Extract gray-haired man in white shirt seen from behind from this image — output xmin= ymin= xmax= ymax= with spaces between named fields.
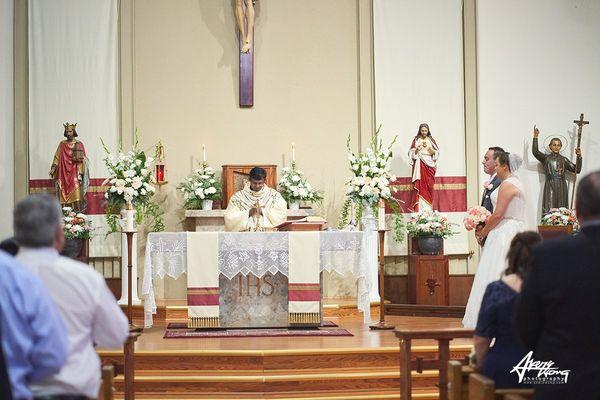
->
xmin=14 ymin=195 xmax=129 ymax=399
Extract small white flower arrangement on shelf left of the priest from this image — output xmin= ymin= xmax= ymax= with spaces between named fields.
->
xmin=177 ymin=163 xmax=221 ymax=210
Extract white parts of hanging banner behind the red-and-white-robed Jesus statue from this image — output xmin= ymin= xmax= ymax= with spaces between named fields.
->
xmin=373 ymin=0 xmax=468 ymax=255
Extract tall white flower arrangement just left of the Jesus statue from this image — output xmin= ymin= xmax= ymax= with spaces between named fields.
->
xmin=339 ymin=125 xmax=406 ymax=243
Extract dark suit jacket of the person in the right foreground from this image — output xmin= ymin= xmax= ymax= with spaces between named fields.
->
xmin=516 ymin=225 xmax=600 ymax=400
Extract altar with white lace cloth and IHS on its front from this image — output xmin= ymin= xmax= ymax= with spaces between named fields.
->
xmin=142 ymin=231 xmax=376 ymax=328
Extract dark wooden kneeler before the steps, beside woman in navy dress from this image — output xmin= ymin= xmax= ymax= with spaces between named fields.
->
xmin=395 ymin=328 xmax=474 ymax=400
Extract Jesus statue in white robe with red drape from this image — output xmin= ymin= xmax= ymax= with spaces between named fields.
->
xmin=408 ymin=124 xmax=440 ymax=211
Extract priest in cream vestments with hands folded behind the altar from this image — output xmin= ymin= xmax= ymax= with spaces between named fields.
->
xmin=225 ymin=167 xmax=287 ymax=232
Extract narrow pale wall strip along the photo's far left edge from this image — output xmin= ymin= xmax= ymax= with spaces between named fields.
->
xmin=0 ymin=0 xmax=15 ymax=240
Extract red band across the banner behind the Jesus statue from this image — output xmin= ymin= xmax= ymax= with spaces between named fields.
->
xmin=386 ymin=176 xmax=467 ymax=213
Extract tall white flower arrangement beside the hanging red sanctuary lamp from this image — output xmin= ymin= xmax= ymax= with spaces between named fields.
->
xmin=101 ymin=131 xmax=164 ymax=232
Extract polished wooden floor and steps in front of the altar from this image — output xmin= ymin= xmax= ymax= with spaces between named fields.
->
xmin=99 ymin=312 xmax=472 ymax=400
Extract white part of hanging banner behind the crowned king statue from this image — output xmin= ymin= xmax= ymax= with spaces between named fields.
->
xmin=29 ymin=0 xmax=118 ymax=179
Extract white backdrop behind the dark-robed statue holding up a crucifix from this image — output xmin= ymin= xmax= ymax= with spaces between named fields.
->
xmin=477 ymin=0 xmax=600 ymax=219
